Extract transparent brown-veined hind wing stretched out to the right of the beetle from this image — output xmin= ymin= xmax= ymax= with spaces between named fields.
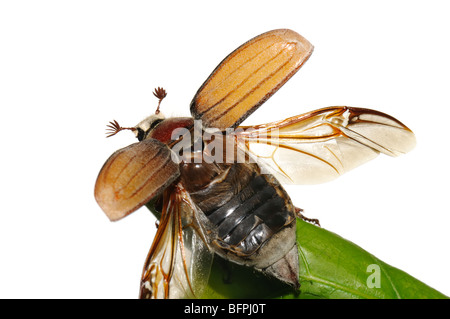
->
xmin=236 ymin=106 xmax=415 ymax=184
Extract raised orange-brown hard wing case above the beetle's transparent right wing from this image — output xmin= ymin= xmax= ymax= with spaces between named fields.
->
xmin=191 ymin=29 xmax=313 ymax=131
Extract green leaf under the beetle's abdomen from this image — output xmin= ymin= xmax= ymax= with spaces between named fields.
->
xmin=202 ymin=220 xmax=448 ymax=299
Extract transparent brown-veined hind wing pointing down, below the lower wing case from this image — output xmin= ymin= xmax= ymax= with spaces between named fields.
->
xmin=140 ymin=184 xmax=213 ymax=299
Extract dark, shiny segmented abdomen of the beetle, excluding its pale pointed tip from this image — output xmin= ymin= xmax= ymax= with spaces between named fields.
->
xmin=181 ymin=164 xmax=295 ymax=268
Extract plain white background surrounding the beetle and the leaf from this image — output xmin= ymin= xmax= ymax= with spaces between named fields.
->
xmin=0 ymin=0 xmax=450 ymax=298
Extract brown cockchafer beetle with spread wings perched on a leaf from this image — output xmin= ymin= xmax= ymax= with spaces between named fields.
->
xmin=95 ymin=29 xmax=415 ymax=298
